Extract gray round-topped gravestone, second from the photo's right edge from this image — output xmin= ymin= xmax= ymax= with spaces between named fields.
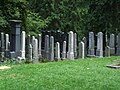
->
xmin=109 ymin=34 xmax=115 ymax=55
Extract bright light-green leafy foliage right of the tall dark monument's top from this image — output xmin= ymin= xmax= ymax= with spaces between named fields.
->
xmin=26 ymin=12 xmax=50 ymax=36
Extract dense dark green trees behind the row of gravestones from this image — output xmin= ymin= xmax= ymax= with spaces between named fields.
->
xmin=0 ymin=0 xmax=120 ymax=38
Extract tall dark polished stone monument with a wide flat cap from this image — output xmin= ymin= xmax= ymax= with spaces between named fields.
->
xmin=10 ymin=20 xmax=21 ymax=58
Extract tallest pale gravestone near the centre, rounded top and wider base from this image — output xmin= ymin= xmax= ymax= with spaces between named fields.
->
xmin=67 ymin=31 xmax=74 ymax=60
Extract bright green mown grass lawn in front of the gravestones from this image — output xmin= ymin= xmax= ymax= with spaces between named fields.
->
xmin=0 ymin=57 xmax=120 ymax=90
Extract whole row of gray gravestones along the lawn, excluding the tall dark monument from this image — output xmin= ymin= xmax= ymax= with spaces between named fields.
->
xmin=0 ymin=31 xmax=120 ymax=63
